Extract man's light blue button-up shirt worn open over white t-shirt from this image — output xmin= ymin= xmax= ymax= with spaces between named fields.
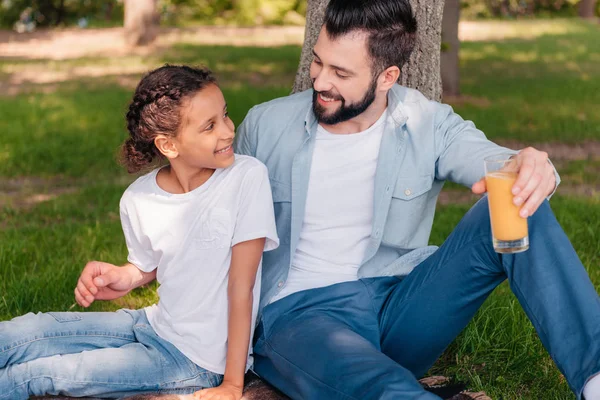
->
xmin=235 ymin=85 xmax=559 ymax=309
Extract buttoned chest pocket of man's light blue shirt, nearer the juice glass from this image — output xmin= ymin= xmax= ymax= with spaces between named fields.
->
xmin=382 ymin=175 xmax=435 ymax=249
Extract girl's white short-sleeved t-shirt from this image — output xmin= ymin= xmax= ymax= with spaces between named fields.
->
xmin=120 ymin=155 xmax=279 ymax=374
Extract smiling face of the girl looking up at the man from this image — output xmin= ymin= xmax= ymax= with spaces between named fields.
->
xmin=172 ymin=84 xmax=234 ymax=169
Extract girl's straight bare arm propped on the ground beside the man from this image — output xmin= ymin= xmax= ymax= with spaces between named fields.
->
xmin=195 ymin=238 xmax=265 ymax=400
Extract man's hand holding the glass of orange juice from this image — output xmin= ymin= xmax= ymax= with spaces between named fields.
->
xmin=471 ymin=147 xmax=556 ymax=218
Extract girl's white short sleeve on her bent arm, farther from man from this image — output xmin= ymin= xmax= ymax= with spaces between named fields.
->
xmin=119 ymin=196 xmax=157 ymax=272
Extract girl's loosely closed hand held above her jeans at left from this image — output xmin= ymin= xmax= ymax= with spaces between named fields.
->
xmin=75 ymin=261 xmax=133 ymax=307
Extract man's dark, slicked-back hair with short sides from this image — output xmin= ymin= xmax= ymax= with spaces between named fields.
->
xmin=324 ymin=0 xmax=417 ymax=76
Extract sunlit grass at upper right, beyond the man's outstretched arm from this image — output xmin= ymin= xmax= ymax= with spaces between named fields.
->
xmin=455 ymin=20 xmax=600 ymax=143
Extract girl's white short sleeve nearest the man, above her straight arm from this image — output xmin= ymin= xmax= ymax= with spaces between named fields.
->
xmin=232 ymin=164 xmax=279 ymax=251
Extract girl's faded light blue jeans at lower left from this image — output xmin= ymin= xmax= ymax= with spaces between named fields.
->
xmin=0 ymin=310 xmax=222 ymax=400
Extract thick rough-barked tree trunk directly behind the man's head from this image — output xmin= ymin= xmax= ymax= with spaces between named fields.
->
xmin=293 ymin=0 xmax=444 ymax=100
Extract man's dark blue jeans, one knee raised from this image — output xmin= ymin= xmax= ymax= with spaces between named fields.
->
xmin=254 ymin=197 xmax=600 ymax=400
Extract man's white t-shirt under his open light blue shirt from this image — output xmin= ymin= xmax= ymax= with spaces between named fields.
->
xmin=272 ymin=111 xmax=387 ymax=302
